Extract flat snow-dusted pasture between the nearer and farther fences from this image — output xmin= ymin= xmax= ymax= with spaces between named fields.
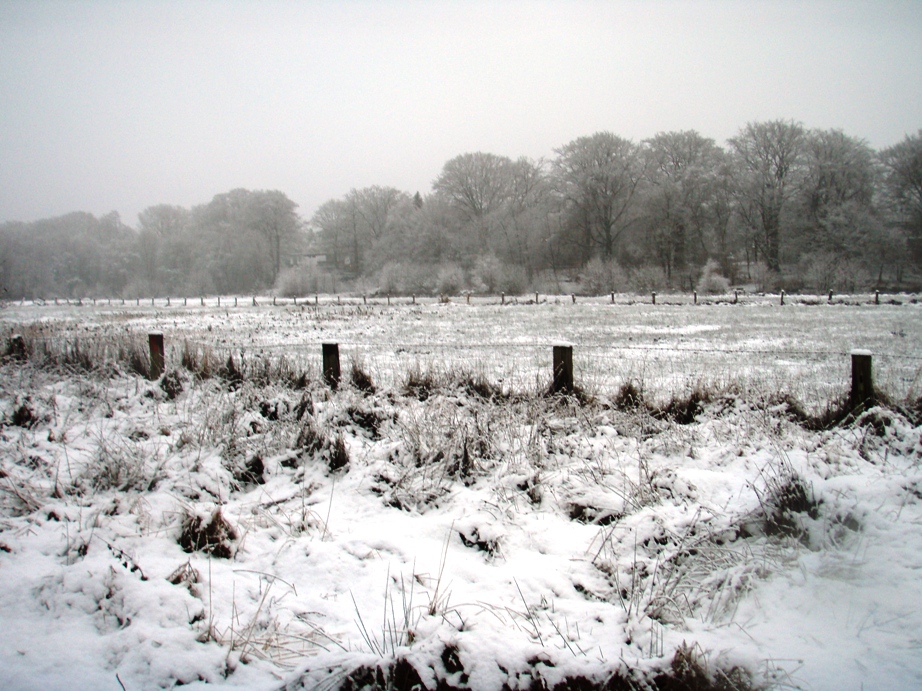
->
xmin=4 ymin=295 xmax=922 ymax=406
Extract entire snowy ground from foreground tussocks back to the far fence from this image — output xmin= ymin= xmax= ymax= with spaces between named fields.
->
xmin=0 ymin=297 xmax=922 ymax=690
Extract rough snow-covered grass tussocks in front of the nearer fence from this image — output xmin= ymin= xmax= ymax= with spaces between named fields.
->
xmin=0 ymin=316 xmax=922 ymax=689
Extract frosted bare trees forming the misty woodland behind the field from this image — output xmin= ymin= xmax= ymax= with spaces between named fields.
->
xmin=0 ymin=120 xmax=922 ymax=300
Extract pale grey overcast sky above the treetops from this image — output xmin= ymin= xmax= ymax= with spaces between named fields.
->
xmin=0 ymin=0 xmax=922 ymax=225
